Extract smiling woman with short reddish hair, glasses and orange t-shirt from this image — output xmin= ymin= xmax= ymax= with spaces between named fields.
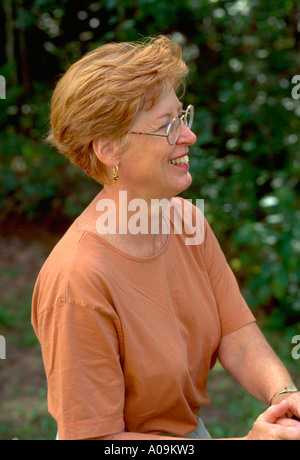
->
xmin=32 ymin=37 xmax=300 ymax=440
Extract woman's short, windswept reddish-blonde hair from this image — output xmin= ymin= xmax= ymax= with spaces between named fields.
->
xmin=47 ymin=36 xmax=188 ymax=184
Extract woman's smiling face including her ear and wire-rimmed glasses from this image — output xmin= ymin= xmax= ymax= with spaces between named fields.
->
xmin=100 ymin=89 xmax=196 ymax=202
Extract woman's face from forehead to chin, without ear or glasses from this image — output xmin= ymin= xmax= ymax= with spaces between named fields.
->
xmin=119 ymin=90 xmax=196 ymax=200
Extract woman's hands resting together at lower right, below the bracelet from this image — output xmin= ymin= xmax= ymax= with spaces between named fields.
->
xmin=244 ymin=400 xmax=300 ymax=441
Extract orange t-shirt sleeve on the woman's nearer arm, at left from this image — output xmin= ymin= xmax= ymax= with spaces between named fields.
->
xmin=38 ymin=299 xmax=125 ymax=440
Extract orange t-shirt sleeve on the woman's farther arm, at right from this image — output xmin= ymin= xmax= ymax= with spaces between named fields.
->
xmin=203 ymin=220 xmax=255 ymax=336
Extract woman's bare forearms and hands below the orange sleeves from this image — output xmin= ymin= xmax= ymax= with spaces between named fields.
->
xmin=84 ymin=323 xmax=300 ymax=441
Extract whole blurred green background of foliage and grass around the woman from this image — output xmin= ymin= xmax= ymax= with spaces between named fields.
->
xmin=0 ymin=0 xmax=300 ymax=439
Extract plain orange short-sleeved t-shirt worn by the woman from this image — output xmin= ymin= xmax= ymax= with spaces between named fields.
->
xmin=32 ymin=199 xmax=255 ymax=440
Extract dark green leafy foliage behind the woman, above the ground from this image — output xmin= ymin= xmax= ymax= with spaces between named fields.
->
xmin=0 ymin=0 xmax=300 ymax=327
